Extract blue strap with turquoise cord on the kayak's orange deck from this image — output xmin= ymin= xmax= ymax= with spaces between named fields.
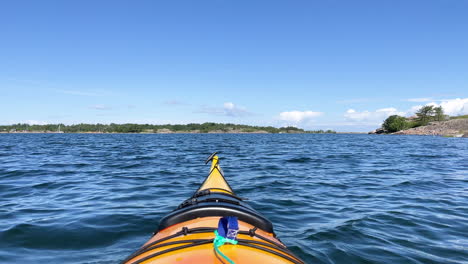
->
xmin=213 ymin=216 xmax=239 ymax=264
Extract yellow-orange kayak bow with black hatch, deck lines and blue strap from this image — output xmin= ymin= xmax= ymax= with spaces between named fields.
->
xmin=122 ymin=153 xmax=304 ymax=264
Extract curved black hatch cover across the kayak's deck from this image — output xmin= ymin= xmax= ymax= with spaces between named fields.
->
xmin=158 ymin=192 xmax=274 ymax=233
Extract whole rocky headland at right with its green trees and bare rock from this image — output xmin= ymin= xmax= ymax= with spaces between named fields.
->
xmin=369 ymin=105 xmax=468 ymax=137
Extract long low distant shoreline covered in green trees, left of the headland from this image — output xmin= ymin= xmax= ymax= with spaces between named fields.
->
xmin=0 ymin=123 xmax=336 ymax=134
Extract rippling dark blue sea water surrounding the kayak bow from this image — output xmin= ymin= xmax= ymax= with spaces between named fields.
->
xmin=0 ymin=134 xmax=468 ymax=263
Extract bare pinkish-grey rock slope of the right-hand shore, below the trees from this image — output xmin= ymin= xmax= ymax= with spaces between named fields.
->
xmin=369 ymin=119 xmax=468 ymax=137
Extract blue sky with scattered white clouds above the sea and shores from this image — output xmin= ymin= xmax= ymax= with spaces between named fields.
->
xmin=0 ymin=0 xmax=468 ymax=131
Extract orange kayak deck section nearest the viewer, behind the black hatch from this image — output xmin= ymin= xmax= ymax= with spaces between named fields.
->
xmin=122 ymin=217 xmax=301 ymax=264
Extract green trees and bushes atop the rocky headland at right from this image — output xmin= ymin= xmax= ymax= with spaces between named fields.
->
xmin=382 ymin=105 xmax=450 ymax=133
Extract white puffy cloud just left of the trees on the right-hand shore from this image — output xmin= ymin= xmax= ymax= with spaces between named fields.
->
xmin=344 ymin=107 xmax=405 ymax=124
